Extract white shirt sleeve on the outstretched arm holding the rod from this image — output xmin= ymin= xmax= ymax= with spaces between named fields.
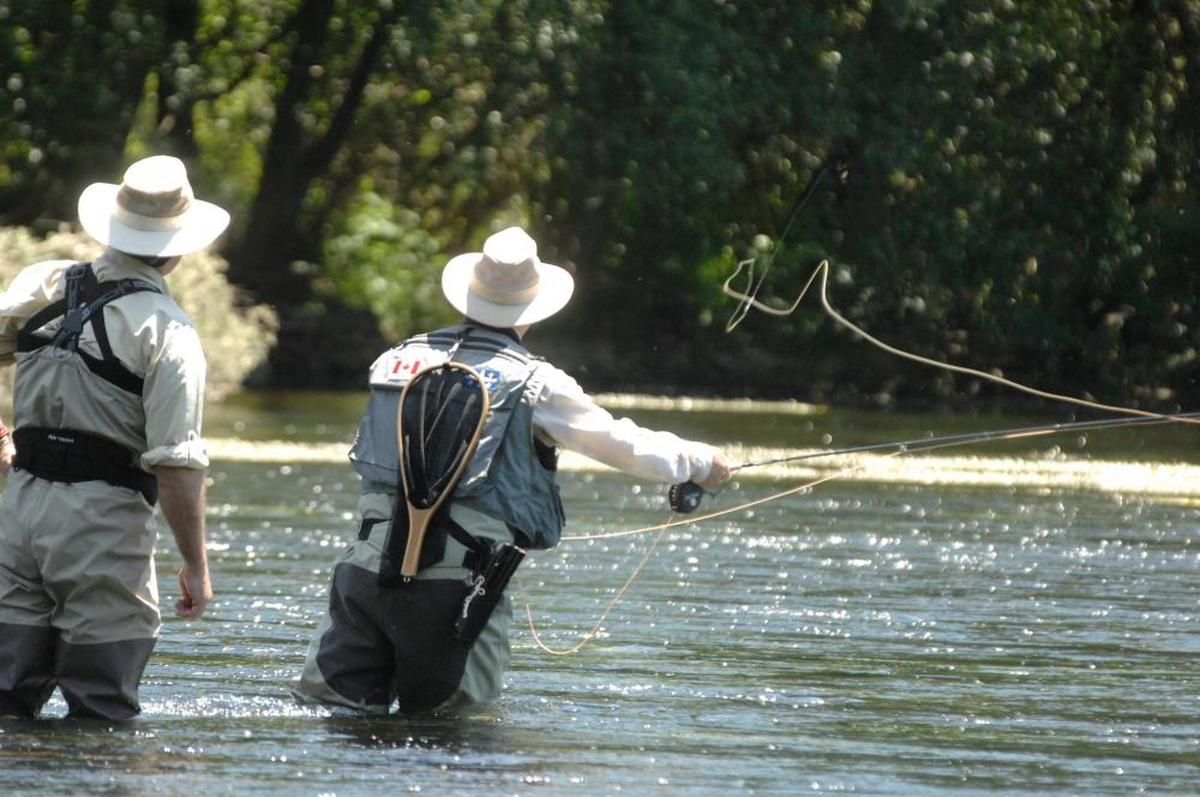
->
xmin=533 ymin=368 xmax=716 ymax=484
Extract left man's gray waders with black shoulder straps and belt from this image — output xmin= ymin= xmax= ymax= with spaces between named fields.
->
xmin=0 ymin=264 xmax=161 ymax=720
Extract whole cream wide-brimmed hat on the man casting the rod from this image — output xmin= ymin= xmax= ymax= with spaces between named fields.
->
xmin=442 ymin=227 xmax=575 ymax=328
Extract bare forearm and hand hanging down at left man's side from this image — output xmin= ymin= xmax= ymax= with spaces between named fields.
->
xmin=155 ymin=466 xmax=212 ymax=619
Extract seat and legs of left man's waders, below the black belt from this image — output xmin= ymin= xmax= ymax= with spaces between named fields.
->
xmin=0 ymin=472 xmax=158 ymax=720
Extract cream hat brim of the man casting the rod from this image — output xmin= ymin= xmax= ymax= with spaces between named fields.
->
xmin=442 ymin=252 xmax=575 ymax=328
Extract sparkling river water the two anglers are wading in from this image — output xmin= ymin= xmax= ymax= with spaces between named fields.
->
xmin=0 ymin=396 xmax=1200 ymax=797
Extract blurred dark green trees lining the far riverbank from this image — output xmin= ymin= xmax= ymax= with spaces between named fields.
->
xmin=0 ymin=0 xmax=1200 ymax=407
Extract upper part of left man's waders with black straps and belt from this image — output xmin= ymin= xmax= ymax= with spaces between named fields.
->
xmin=13 ymin=263 xmax=162 ymax=504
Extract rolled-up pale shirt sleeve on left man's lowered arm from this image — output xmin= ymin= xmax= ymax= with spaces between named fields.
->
xmin=142 ymin=322 xmax=209 ymax=469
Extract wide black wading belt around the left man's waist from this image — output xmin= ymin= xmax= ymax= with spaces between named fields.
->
xmin=12 ymin=426 xmax=158 ymax=505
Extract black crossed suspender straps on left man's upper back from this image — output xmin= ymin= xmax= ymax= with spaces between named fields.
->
xmin=17 ymin=263 xmax=162 ymax=396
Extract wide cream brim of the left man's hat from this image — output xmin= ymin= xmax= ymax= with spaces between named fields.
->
xmin=79 ymin=182 xmax=229 ymax=257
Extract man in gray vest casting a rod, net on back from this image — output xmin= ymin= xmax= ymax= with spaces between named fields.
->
xmin=295 ymin=227 xmax=730 ymax=713
